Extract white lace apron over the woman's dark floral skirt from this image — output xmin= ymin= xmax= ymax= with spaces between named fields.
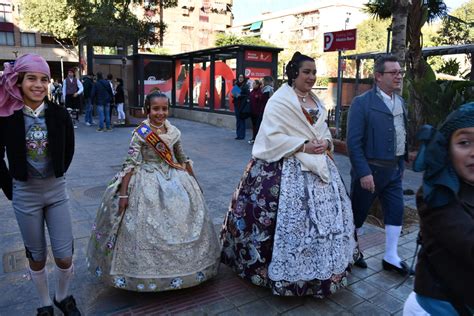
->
xmin=268 ymin=157 xmax=356 ymax=282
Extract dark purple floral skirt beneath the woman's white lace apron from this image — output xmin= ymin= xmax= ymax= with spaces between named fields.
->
xmin=221 ymin=159 xmax=356 ymax=298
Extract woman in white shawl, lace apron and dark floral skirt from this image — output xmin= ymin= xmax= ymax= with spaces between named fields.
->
xmin=221 ymin=52 xmax=357 ymax=297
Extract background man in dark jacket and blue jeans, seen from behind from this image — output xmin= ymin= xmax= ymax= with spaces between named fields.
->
xmin=91 ymin=72 xmax=113 ymax=132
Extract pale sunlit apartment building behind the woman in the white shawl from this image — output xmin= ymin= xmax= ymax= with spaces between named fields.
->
xmin=227 ymin=0 xmax=369 ymax=74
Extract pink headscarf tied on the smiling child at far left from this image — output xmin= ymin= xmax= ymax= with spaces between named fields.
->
xmin=0 ymin=54 xmax=51 ymax=116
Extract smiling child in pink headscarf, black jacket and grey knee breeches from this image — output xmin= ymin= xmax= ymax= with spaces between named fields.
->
xmin=0 ymin=54 xmax=80 ymax=315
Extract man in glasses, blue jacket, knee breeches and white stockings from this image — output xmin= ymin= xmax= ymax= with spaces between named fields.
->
xmin=347 ymin=56 xmax=413 ymax=275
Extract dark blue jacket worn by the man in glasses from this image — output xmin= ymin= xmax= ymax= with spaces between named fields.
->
xmin=347 ymin=85 xmax=408 ymax=179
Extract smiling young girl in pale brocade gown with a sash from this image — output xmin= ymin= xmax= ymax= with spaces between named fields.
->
xmin=87 ymin=92 xmax=220 ymax=292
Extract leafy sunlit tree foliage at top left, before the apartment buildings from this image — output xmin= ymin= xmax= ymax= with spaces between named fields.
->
xmin=20 ymin=0 xmax=178 ymax=47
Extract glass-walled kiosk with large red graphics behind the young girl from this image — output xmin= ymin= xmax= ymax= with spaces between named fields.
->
xmin=129 ymin=45 xmax=282 ymax=113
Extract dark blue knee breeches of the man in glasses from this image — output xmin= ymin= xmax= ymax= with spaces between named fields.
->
xmin=351 ymin=164 xmax=404 ymax=228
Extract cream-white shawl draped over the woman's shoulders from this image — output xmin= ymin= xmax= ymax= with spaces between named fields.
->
xmin=252 ymin=84 xmax=332 ymax=183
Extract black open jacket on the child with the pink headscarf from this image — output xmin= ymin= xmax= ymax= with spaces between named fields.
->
xmin=0 ymin=100 xmax=74 ymax=199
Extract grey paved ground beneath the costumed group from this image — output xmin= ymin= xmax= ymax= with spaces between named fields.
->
xmin=0 ymin=119 xmax=421 ymax=316
